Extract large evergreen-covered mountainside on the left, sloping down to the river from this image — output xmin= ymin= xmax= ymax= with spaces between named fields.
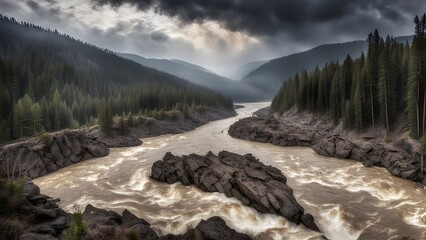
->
xmin=0 ymin=15 xmax=232 ymax=142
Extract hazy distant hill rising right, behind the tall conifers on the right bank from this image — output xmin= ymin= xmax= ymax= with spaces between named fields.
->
xmin=242 ymin=36 xmax=413 ymax=98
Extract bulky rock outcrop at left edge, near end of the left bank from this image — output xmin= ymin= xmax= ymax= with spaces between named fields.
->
xmin=0 ymin=130 xmax=113 ymax=179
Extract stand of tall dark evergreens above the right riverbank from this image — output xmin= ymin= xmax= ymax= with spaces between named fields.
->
xmin=271 ymin=15 xmax=426 ymax=138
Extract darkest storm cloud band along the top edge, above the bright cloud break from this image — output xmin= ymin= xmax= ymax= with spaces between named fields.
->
xmin=93 ymin=0 xmax=426 ymax=37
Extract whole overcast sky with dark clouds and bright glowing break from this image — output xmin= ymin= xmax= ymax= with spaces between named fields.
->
xmin=0 ymin=0 xmax=426 ymax=73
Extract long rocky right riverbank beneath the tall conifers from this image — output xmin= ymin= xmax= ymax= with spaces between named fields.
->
xmin=228 ymin=114 xmax=425 ymax=183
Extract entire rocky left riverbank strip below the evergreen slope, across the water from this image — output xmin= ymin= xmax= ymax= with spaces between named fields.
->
xmin=0 ymin=108 xmax=236 ymax=179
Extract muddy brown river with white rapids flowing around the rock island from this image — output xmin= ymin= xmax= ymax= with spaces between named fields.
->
xmin=34 ymin=103 xmax=426 ymax=240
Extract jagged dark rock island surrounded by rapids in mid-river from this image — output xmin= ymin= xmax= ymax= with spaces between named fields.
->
xmin=151 ymin=151 xmax=319 ymax=231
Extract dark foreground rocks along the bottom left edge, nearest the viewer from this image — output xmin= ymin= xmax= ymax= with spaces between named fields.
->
xmin=0 ymin=182 xmax=251 ymax=240
